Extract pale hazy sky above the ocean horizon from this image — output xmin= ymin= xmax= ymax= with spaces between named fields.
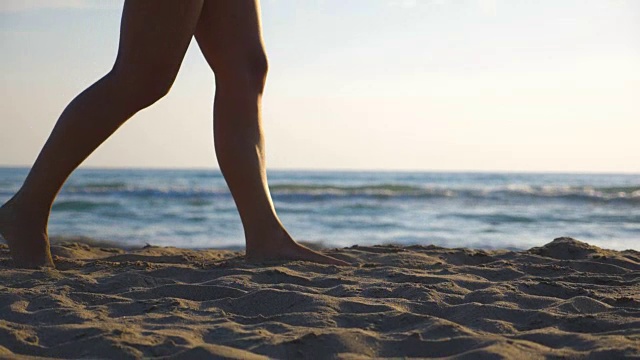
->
xmin=0 ymin=0 xmax=640 ymax=173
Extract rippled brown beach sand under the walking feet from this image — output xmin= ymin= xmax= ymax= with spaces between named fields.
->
xmin=0 ymin=238 xmax=640 ymax=359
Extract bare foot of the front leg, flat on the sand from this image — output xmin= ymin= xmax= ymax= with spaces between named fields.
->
xmin=246 ymin=230 xmax=351 ymax=266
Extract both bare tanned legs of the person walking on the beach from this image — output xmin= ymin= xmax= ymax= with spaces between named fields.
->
xmin=0 ymin=0 xmax=348 ymax=268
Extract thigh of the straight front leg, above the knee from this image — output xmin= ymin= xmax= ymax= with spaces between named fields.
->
xmin=195 ymin=0 xmax=266 ymax=77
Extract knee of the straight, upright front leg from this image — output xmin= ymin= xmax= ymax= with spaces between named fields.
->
xmin=214 ymin=50 xmax=269 ymax=94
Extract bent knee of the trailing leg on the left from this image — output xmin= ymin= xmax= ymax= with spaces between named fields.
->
xmin=110 ymin=66 xmax=177 ymax=111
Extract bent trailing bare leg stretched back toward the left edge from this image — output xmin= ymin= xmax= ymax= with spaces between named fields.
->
xmin=0 ymin=0 xmax=203 ymax=267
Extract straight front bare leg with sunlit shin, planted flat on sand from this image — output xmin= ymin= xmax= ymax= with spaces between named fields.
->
xmin=195 ymin=0 xmax=347 ymax=265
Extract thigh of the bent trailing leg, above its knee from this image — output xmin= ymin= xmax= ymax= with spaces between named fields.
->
xmin=114 ymin=0 xmax=204 ymax=77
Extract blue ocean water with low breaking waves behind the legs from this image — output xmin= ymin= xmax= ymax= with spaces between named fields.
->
xmin=0 ymin=168 xmax=640 ymax=250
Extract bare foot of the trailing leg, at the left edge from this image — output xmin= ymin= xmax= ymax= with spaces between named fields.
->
xmin=0 ymin=201 xmax=55 ymax=269
